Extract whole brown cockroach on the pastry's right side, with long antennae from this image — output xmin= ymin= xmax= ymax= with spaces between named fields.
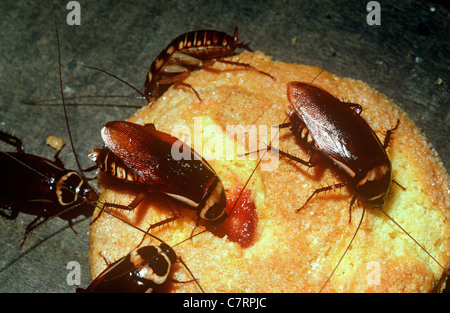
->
xmin=279 ymin=82 xmax=447 ymax=289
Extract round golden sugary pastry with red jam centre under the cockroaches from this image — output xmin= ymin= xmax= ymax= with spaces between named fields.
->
xmin=90 ymin=53 xmax=450 ymax=292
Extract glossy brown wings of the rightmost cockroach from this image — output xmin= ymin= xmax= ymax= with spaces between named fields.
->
xmin=288 ymin=82 xmax=390 ymax=178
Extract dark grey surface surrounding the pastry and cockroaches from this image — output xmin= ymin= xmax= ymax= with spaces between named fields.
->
xmin=0 ymin=0 xmax=450 ymax=292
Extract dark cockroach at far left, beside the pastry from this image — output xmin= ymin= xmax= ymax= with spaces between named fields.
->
xmin=0 ymin=131 xmax=98 ymax=247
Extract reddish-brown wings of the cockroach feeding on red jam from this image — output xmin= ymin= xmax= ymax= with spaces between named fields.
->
xmin=102 ymin=121 xmax=216 ymax=203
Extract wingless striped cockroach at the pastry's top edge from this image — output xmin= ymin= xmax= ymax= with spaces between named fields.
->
xmin=144 ymin=27 xmax=273 ymax=101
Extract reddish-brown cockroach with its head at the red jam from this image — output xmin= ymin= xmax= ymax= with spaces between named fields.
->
xmin=90 ymin=121 xmax=227 ymax=227
